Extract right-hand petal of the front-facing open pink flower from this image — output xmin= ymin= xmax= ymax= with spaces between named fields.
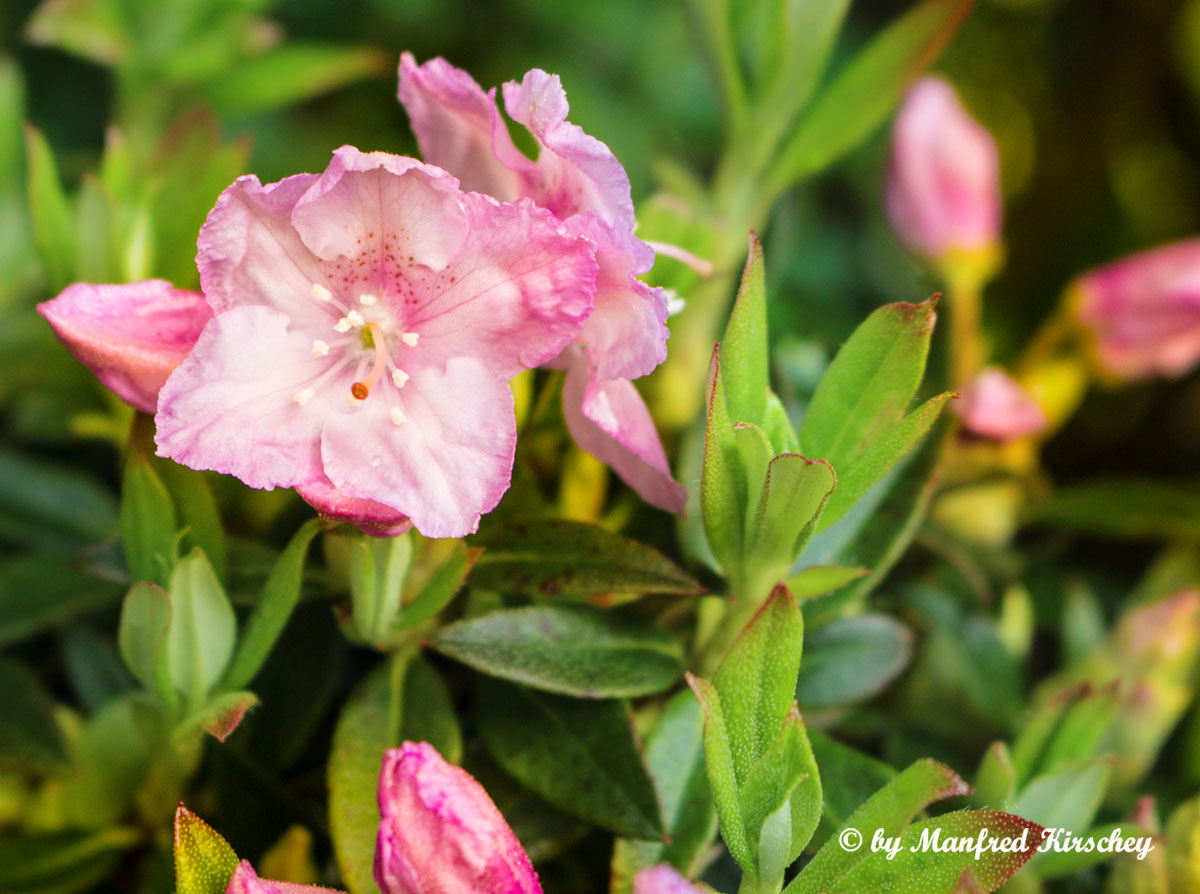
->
xmin=407 ymin=193 xmax=596 ymax=378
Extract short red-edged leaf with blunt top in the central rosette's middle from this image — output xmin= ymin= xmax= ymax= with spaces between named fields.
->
xmin=751 ymin=454 xmax=838 ymax=569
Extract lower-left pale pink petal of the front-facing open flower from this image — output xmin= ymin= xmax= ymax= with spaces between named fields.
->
xmin=155 ymin=306 xmax=353 ymax=488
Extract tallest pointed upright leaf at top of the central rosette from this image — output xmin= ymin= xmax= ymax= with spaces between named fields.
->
xmin=721 ymin=233 xmax=769 ymax=426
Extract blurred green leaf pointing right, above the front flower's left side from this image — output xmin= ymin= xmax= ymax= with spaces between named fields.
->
xmin=205 ymin=42 xmax=394 ymax=118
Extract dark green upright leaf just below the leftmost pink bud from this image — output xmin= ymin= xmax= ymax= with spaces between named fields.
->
xmin=121 ymin=451 xmax=176 ymax=586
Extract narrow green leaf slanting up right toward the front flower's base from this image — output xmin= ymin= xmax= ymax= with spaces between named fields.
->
xmin=221 ymin=518 xmax=320 ymax=689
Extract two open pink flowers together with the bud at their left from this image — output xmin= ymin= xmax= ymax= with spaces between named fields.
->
xmin=41 ymin=55 xmax=685 ymax=536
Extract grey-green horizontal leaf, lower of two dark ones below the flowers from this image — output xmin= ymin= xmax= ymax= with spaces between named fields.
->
xmin=432 ymin=606 xmax=683 ymax=698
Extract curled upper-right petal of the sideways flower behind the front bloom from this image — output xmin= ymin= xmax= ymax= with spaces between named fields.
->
xmin=504 ymin=68 xmax=635 ymax=229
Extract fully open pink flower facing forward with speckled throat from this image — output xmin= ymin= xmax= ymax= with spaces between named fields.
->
xmin=156 ymin=146 xmax=596 ymax=536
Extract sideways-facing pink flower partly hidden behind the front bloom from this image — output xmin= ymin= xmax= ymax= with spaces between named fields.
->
xmin=400 ymin=53 xmax=686 ymax=512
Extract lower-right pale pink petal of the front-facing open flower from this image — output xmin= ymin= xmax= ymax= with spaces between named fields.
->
xmin=322 ymin=356 xmax=517 ymax=538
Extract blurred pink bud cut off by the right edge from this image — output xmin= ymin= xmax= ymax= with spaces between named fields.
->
xmin=1074 ymin=239 xmax=1200 ymax=382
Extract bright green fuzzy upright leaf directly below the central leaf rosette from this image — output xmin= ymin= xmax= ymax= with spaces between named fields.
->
xmin=713 ymin=586 xmax=804 ymax=785
